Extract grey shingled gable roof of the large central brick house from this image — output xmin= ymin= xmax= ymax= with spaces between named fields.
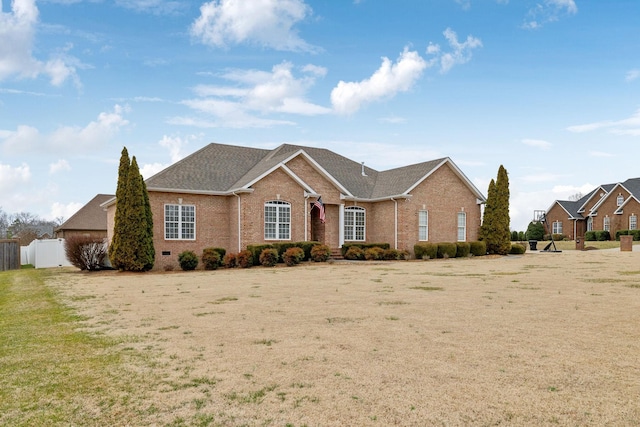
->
xmin=146 ymin=143 xmax=485 ymax=202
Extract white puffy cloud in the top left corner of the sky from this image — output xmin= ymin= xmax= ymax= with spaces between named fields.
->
xmin=0 ymin=0 xmax=79 ymax=86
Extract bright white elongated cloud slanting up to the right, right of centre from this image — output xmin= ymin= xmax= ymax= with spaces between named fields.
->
xmin=331 ymin=48 xmax=427 ymax=114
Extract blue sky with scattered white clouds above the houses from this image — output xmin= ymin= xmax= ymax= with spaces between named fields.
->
xmin=0 ymin=0 xmax=640 ymax=230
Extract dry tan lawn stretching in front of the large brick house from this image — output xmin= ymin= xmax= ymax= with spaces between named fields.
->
xmin=50 ymin=250 xmax=640 ymax=426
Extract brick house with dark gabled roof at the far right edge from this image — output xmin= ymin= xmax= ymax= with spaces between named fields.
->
xmin=546 ymin=178 xmax=640 ymax=240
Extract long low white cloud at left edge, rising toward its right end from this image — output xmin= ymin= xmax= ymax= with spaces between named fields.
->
xmin=0 ymin=105 xmax=129 ymax=153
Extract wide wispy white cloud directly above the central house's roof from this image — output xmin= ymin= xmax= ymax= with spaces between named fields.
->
xmin=180 ymin=62 xmax=331 ymax=128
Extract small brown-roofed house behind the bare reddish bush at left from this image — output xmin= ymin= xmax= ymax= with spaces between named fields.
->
xmin=54 ymin=194 xmax=115 ymax=238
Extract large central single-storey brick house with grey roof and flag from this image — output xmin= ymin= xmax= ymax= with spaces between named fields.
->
xmin=104 ymin=144 xmax=485 ymax=268
